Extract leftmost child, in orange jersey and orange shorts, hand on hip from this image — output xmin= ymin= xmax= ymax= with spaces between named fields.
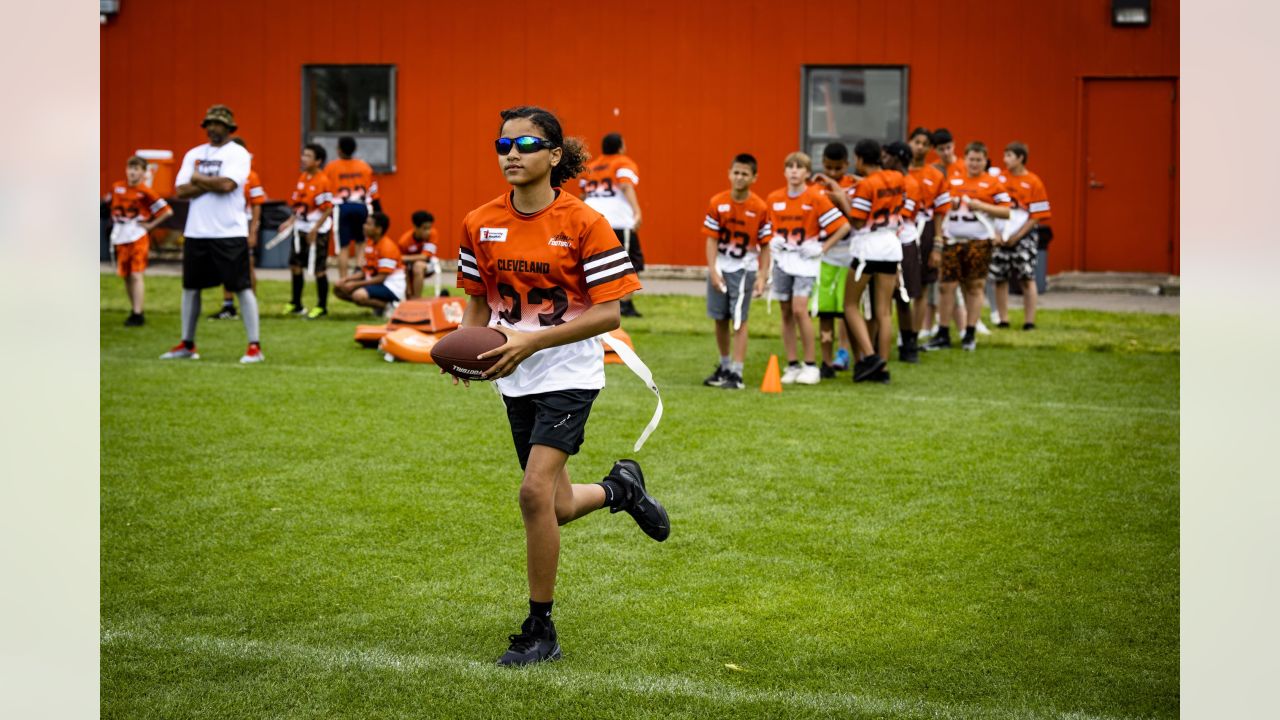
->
xmin=111 ymin=155 xmax=173 ymax=328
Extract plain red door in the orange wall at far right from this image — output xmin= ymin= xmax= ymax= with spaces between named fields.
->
xmin=1083 ymin=79 xmax=1178 ymax=273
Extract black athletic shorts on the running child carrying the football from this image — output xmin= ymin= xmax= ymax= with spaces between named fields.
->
xmin=502 ymin=389 xmax=600 ymax=469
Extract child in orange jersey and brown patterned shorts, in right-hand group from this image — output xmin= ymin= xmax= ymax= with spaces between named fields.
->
xmin=924 ymin=142 xmax=1011 ymax=351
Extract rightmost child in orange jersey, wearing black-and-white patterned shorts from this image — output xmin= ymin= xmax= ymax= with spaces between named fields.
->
xmin=991 ymin=142 xmax=1052 ymax=331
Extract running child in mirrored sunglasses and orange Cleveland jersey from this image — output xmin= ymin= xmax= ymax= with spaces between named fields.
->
xmin=458 ymin=106 xmax=671 ymax=666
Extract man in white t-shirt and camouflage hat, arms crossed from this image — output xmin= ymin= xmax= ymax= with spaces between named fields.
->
xmin=160 ymin=105 xmax=262 ymax=363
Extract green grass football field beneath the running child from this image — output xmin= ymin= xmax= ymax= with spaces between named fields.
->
xmin=101 ymin=275 xmax=1179 ymax=719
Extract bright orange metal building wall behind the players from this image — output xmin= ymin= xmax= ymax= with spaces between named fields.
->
xmin=101 ymin=0 xmax=1179 ymax=272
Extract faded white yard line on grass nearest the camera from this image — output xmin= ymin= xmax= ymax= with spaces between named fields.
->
xmin=101 ymin=629 xmax=1141 ymax=720
